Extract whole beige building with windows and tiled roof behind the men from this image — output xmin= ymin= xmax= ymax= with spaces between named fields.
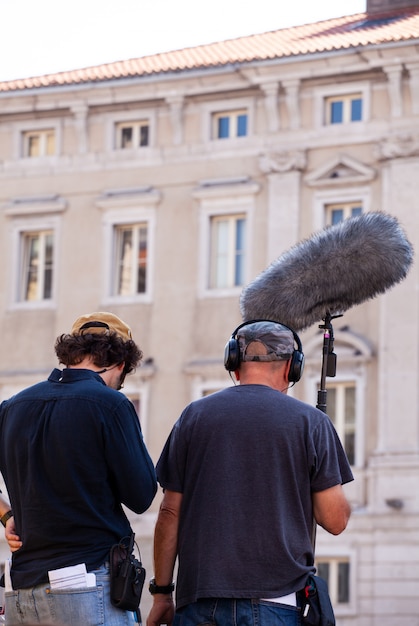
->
xmin=0 ymin=0 xmax=419 ymax=626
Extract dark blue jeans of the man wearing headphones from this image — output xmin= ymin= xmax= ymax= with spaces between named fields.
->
xmin=173 ymin=598 xmax=301 ymax=626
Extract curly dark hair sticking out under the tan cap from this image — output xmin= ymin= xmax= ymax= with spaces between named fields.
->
xmin=55 ymin=332 xmax=143 ymax=375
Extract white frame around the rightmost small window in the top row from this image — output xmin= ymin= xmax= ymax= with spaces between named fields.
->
xmin=313 ymin=82 xmax=371 ymax=130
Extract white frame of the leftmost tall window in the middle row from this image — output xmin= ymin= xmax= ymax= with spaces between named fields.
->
xmin=10 ymin=216 xmax=60 ymax=309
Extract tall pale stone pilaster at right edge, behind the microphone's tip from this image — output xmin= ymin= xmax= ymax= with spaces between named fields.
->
xmin=367 ymin=136 xmax=419 ymax=512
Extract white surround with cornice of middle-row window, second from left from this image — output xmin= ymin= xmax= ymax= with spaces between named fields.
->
xmin=96 ymin=193 xmax=160 ymax=304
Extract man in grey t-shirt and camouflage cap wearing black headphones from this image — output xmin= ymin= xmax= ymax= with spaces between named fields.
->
xmin=147 ymin=321 xmax=353 ymax=626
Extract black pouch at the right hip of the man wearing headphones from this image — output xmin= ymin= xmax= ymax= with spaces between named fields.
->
xmin=297 ymin=574 xmax=336 ymax=626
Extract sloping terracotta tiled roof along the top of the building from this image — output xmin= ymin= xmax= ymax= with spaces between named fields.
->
xmin=0 ymin=8 xmax=419 ymax=92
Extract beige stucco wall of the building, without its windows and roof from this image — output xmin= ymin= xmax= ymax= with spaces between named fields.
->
xmin=0 ymin=33 xmax=419 ymax=626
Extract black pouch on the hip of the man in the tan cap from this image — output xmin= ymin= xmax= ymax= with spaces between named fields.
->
xmin=110 ymin=533 xmax=146 ymax=613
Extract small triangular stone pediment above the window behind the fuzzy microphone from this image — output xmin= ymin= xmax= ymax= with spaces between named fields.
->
xmin=305 ymin=154 xmax=375 ymax=187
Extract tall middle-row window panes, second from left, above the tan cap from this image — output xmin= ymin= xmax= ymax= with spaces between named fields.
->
xmin=113 ymin=223 xmax=148 ymax=296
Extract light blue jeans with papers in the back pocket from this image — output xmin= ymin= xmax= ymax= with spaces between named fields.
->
xmin=5 ymin=565 xmax=136 ymax=626
